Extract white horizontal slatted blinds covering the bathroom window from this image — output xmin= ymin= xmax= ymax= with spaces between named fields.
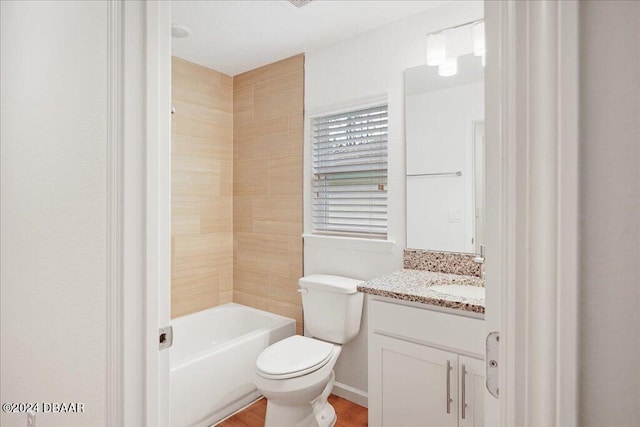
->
xmin=313 ymin=105 xmax=388 ymax=238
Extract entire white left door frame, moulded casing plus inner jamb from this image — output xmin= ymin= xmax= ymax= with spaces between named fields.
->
xmin=105 ymin=0 xmax=171 ymax=427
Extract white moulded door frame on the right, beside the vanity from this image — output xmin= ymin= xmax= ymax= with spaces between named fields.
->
xmin=485 ymin=0 xmax=579 ymax=427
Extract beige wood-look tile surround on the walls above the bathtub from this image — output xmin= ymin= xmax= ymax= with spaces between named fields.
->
xmin=172 ymin=55 xmax=304 ymax=333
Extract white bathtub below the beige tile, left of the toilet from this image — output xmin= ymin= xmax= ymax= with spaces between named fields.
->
xmin=169 ymin=303 xmax=296 ymax=427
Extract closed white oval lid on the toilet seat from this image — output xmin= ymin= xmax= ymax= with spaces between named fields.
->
xmin=256 ymin=335 xmax=334 ymax=378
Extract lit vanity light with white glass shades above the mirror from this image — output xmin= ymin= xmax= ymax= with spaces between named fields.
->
xmin=427 ymin=19 xmax=487 ymax=77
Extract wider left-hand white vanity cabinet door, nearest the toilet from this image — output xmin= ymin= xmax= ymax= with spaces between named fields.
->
xmin=369 ymin=334 xmax=458 ymax=427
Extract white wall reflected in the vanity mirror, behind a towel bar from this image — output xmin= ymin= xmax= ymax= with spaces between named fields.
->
xmin=405 ymin=82 xmax=484 ymax=252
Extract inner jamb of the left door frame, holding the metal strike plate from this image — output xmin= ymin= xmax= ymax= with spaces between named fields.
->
xmin=145 ymin=1 xmax=171 ymax=427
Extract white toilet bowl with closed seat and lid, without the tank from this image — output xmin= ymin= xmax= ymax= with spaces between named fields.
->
xmin=254 ymin=335 xmax=342 ymax=427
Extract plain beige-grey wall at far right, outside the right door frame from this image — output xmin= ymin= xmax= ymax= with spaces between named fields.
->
xmin=578 ymin=1 xmax=640 ymax=427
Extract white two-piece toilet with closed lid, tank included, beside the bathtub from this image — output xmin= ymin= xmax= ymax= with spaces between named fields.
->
xmin=254 ymin=274 xmax=364 ymax=427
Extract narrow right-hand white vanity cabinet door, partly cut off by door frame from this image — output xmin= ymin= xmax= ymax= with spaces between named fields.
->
xmin=458 ymin=356 xmax=485 ymax=427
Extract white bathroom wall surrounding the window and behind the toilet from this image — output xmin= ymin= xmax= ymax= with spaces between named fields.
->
xmin=304 ymin=1 xmax=483 ymax=402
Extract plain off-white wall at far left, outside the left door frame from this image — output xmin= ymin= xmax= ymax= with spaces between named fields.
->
xmin=0 ymin=1 xmax=107 ymax=427
